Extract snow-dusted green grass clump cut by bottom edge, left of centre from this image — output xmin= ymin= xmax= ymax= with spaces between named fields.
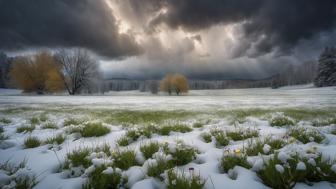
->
xmin=82 ymin=165 xmax=127 ymax=189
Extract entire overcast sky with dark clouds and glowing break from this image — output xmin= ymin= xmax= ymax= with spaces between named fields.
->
xmin=0 ymin=0 xmax=336 ymax=79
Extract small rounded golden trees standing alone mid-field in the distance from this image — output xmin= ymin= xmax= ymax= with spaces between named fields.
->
xmin=160 ymin=74 xmax=189 ymax=95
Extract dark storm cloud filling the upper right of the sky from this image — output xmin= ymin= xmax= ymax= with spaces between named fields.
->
xmin=150 ymin=0 xmax=336 ymax=56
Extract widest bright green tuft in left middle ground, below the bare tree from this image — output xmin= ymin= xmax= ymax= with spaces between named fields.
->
xmin=80 ymin=122 xmax=111 ymax=137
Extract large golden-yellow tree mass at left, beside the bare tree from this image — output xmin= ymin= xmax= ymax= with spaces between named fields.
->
xmin=9 ymin=52 xmax=64 ymax=94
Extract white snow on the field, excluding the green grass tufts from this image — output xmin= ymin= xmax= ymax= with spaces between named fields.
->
xmin=0 ymin=86 xmax=336 ymax=189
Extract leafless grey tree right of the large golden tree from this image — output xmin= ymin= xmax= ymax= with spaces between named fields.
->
xmin=55 ymin=49 xmax=98 ymax=95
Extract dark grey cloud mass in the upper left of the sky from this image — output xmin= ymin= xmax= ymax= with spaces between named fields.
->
xmin=0 ymin=0 xmax=142 ymax=58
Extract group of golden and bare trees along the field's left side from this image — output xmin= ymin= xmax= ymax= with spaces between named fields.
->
xmin=1 ymin=49 xmax=101 ymax=95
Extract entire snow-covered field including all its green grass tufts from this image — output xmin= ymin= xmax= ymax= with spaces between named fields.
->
xmin=0 ymin=86 xmax=336 ymax=189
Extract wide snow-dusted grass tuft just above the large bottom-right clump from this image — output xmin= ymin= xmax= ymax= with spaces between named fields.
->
xmin=288 ymin=128 xmax=325 ymax=144
